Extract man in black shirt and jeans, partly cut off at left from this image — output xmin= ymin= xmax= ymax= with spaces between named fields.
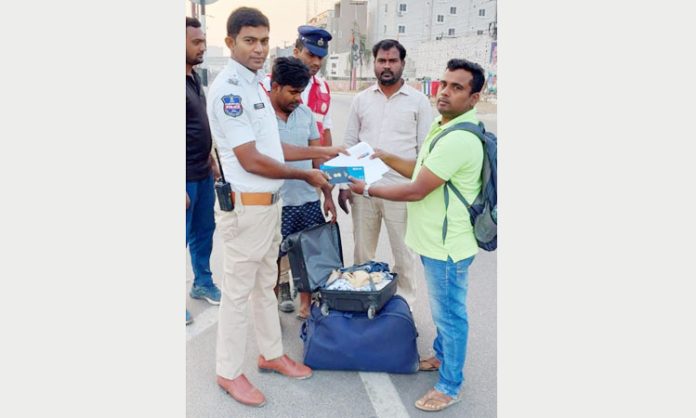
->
xmin=186 ymin=17 xmax=220 ymax=324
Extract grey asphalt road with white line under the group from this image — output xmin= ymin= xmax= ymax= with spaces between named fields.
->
xmin=188 ymin=93 xmax=497 ymax=418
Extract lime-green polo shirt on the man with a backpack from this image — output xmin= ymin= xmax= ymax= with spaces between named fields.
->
xmin=405 ymin=109 xmax=483 ymax=262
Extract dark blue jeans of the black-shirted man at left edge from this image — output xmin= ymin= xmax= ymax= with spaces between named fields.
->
xmin=186 ymin=175 xmax=215 ymax=286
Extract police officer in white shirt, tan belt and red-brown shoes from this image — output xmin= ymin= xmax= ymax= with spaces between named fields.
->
xmin=208 ymin=7 xmax=329 ymax=406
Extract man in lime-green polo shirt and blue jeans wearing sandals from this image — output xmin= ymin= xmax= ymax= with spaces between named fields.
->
xmin=350 ymin=59 xmax=485 ymax=411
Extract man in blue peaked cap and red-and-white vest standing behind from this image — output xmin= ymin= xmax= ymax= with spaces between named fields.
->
xmin=293 ymin=25 xmax=332 ymax=146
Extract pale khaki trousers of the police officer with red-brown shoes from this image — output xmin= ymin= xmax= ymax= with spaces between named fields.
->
xmin=216 ymin=201 xmax=283 ymax=379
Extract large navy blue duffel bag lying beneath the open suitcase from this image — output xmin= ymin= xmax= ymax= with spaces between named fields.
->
xmin=300 ymin=295 xmax=418 ymax=373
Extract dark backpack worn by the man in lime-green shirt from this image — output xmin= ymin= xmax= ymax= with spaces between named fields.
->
xmin=430 ymin=122 xmax=498 ymax=251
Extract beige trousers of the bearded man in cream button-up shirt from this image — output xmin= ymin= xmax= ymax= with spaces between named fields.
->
xmin=351 ymin=193 xmax=422 ymax=309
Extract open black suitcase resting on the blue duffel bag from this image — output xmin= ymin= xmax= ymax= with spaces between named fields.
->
xmin=281 ymin=222 xmax=398 ymax=319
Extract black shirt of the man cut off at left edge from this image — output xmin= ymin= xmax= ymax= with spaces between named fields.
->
xmin=186 ymin=71 xmax=213 ymax=181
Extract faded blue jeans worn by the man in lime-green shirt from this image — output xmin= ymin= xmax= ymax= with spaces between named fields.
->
xmin=421 ymin=256 xmax=474 ymax=397
